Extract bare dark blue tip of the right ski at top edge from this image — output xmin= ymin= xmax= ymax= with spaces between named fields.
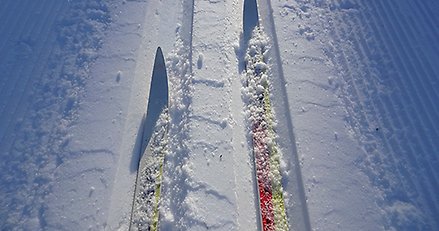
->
xmin=236 ymin=0 xmax=259 ymax=73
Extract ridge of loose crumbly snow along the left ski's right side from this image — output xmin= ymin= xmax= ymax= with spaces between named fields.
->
xmin=160 ymin=31 xmax=192 ymax=227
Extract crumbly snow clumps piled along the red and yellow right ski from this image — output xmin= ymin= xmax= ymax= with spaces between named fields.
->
xmin=242 ymin=27 xmax=288 ymax=230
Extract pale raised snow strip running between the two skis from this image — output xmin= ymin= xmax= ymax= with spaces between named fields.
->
xmin=162 ymin=1 xmax=253 ymax=230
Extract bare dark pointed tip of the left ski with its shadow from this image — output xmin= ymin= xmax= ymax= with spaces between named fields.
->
xmin=131 ymin=47 xmax=168 ymax=171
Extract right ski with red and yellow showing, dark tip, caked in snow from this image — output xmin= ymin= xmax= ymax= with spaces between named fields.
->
xmin=244 ymin=0 xmax=288 ymax=231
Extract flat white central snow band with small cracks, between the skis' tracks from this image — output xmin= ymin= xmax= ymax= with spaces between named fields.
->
xmin=177 ymin=1 xmax=246 ymax=229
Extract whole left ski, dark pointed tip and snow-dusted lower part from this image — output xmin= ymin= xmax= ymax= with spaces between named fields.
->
xmin=130 ymin=47 xmax=169 ymax=230
